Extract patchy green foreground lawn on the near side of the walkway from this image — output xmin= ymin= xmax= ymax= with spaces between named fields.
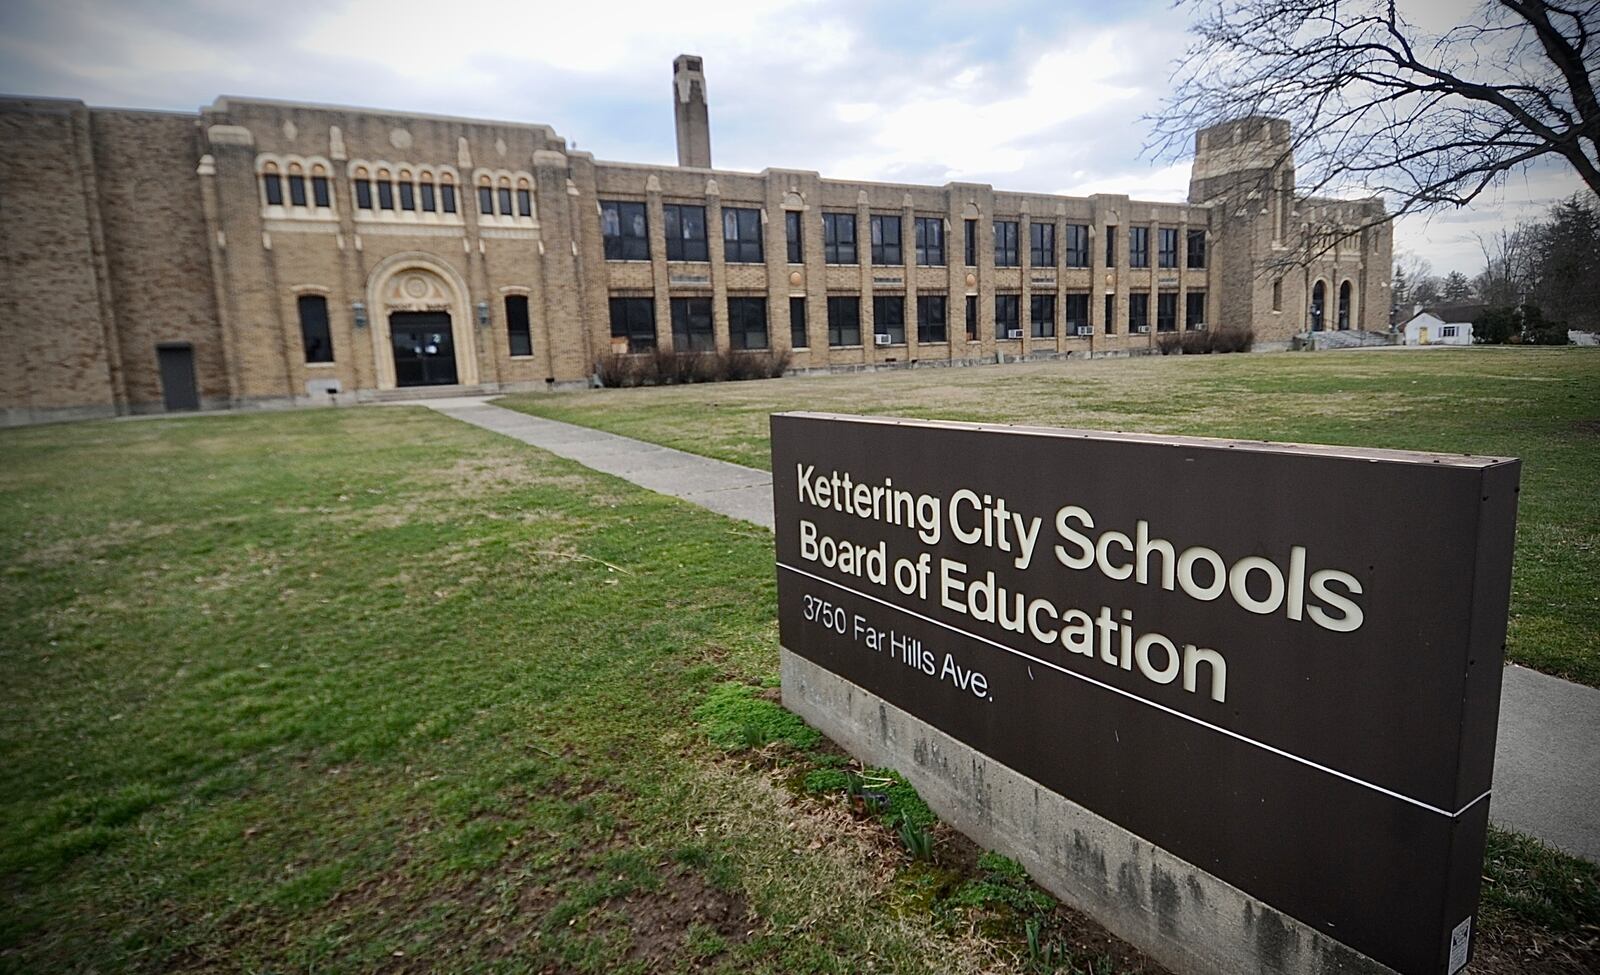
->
xmin=0 ymin=398 xmax=1600 ymax=975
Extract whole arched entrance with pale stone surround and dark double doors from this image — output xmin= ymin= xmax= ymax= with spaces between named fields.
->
xmin=366 ymin=255 xmax=478 ymax=389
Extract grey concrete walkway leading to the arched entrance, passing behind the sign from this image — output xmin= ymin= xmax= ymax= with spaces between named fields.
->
xmin=406 ymin=397 xmax=1600 ymax=863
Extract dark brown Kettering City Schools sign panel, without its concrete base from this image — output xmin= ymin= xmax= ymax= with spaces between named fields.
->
xmin=771 ymin=413 xmax=1520 ymax=975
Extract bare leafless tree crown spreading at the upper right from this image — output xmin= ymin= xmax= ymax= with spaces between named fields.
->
xmin=1150 ymin=0 xmax=1600 ymax=224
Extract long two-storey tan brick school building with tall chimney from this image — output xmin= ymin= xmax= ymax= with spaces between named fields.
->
xmin=0 ymin=56 xmax=1390 ymax=424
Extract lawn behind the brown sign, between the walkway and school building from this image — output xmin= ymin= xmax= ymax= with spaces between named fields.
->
xmin=499 ymin=347 xmax=1600 ymax=687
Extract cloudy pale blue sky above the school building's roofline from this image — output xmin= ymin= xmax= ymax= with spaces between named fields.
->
xmin=0 ymin=0 xmax=1579 ymax=274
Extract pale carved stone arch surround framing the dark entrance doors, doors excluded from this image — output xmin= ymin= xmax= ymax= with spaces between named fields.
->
xmin=366 ymin=253 xmax=478 ymax=389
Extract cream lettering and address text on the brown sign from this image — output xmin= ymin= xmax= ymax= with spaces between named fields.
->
xmin=795 ymin=463 xmax=1362 ymax=703
